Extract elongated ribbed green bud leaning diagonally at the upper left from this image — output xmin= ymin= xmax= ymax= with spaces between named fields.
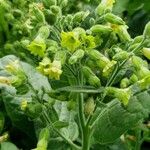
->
xmin=32 ymin=5 xmax=45 ymax=23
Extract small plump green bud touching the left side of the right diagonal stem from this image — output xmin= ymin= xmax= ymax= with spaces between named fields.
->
xmin=112 ymin=51 xmax=130 ymax=61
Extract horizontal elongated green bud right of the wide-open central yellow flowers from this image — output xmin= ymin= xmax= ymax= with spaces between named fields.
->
xmin=90 ymin=24 xmax=112 ymax=34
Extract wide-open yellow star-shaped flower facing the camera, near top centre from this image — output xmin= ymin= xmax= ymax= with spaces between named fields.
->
xmin=61 ymin=32 xmax=81 ymax=52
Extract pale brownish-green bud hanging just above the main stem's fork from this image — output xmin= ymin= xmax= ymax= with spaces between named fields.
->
xmin=84 ymin=97 xmax=95 ymax=116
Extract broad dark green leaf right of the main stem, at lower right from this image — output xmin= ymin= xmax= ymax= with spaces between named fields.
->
xmin=93 ymin=92 xmax=150 ymax=144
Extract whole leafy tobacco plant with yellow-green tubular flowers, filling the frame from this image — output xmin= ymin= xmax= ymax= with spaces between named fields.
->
xmin=0 ymin=0 xmax=150 ymax=150
